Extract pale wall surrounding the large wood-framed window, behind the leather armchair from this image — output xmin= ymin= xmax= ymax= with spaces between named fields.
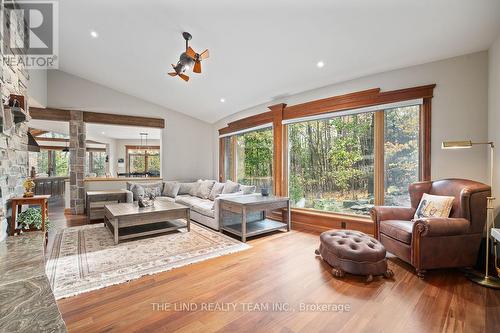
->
xmin=212 ymin=52 xmax=488 ymax=182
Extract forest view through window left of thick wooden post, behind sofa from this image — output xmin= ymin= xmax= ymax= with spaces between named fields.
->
xmin=221 ymin=127 xmax=273 ymax=191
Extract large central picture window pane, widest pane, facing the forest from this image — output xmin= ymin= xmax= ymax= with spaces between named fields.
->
xmin=288 ymin=113 xmax=374 ymax=214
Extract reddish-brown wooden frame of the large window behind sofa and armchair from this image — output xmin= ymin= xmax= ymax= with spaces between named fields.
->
xmin=219 ymin=84 xmax=436 ymax=233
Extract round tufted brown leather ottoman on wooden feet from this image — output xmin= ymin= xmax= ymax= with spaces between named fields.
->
xmin=316 ymin=230 xmax=394 ymax=282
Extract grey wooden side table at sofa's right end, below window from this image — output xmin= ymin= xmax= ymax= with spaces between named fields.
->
xmin=219 ymin=195 xmax=291 ymax=242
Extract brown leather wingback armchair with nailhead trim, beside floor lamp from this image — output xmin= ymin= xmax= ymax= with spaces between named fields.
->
xmin=372 ymin=179 xmax=491 ymax=278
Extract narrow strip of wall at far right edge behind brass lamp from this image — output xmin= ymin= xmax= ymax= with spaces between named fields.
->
xmin=488 ymin=36 xmax=500 ymax=220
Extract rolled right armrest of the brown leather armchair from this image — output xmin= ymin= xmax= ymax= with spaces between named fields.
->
xmin=413 ymin=217 xmax=470 ymax=237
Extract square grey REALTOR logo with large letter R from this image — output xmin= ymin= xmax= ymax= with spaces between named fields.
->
xmin=0 ymin=0 xmax=59 ymax=69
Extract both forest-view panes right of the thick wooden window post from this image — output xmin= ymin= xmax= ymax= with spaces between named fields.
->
xmin=288 ymin=105 xmax=421 ymax=216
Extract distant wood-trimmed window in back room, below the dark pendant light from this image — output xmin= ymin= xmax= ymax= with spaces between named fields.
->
xmin=125 ymin=146 xmax=160 ymax=177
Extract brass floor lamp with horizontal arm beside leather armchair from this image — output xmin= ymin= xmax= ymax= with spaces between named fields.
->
xmin=441 ymin=141 xmax=500 ymax=289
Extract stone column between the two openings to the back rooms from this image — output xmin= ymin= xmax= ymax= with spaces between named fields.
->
xmin=69 ymin=111 xmax=87 ymax=215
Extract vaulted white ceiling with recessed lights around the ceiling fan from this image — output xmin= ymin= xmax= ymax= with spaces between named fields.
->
xmin=60 ymin=0 xmax=500 ymax=123
